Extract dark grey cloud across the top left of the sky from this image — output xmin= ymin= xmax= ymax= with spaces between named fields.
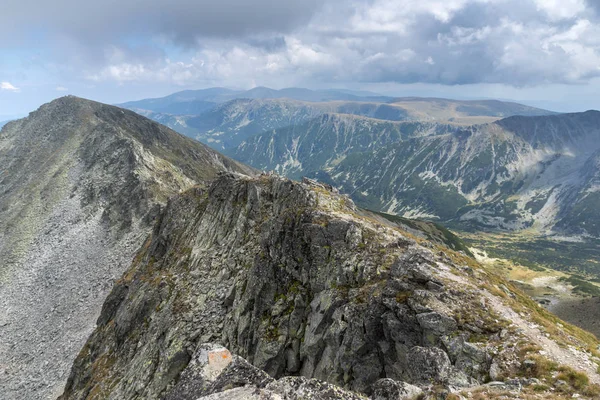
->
xmin=0 ymin=0 xmax=321 ymax=45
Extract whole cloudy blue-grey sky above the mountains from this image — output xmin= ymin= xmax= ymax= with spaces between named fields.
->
xmin=0 ymin=0 xmax=600 ymax=120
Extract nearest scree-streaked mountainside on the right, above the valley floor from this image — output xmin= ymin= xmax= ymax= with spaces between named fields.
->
xmin=308 ymin=111 xmax=600 ymax=236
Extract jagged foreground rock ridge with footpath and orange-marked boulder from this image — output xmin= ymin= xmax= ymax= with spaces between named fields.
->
xmin=60 ymin=173 xmax=600 ymax=400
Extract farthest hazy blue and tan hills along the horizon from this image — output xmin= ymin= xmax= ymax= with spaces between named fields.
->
xmin=121 ymin=88 xmax=552 ymax=150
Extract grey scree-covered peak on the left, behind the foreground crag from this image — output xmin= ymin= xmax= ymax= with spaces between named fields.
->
xmin=0 ymin=97 xmax=252 ymax=399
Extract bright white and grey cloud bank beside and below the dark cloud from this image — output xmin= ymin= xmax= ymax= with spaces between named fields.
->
xmin=18 ymin=0 xmax=600 ymax=87
